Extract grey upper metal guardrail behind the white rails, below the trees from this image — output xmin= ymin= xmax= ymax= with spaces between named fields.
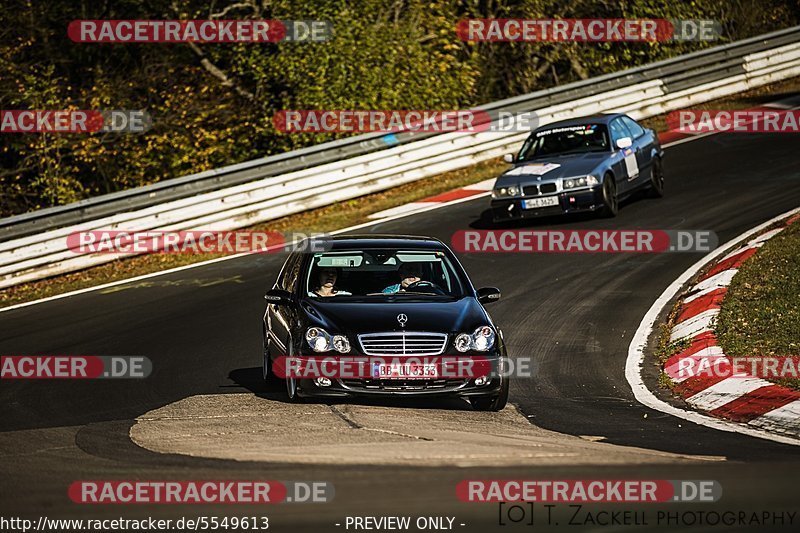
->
xmin=6 ymin=26 xmax=800 ymax=242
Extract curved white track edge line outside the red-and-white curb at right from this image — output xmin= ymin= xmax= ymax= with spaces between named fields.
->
xmin=625 ymin=207 xmax=800 ymax=446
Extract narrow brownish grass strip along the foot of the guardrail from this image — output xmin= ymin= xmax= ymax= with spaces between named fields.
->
xmin=0 ymin=78 xmax=800 ymax=308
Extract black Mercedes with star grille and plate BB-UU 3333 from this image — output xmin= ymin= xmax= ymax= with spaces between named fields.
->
xmin=263 ymin=235 xmax=509 ymax=411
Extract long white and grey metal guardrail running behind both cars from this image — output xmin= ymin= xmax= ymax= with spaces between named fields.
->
xmin=0 ymin=27 xmax=800 ymax=288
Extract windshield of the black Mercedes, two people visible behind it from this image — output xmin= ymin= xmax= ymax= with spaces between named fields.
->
xmin=305 ymin=248 xmax=467 ymax=301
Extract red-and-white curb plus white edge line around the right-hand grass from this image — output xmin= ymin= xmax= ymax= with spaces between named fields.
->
xmin=626 ymin=210 xmax=800 ymax=444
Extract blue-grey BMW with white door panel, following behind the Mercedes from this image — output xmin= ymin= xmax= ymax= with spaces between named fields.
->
xmin=491 ymin=113 xmax=664 ymax=222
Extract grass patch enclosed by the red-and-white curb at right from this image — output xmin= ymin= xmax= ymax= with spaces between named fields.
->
xmin=715 ymin=218 xmax=800 ymax=389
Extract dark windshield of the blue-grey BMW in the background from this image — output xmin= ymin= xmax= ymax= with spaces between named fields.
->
xmin=519 ymin=124 xmax=611 ymax=161
